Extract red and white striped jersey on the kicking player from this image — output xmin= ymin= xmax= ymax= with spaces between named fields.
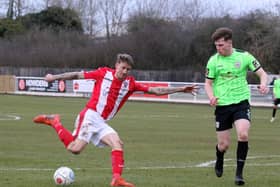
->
xmin=84 ymin=67 xmax=149 ymax=120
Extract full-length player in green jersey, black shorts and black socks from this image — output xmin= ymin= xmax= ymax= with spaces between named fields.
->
xmin=205 ymin=27 xmax=268 ymax=185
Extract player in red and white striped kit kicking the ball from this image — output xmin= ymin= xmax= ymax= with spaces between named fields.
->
xmin=33 ymin=54 xmax=198 ymax=187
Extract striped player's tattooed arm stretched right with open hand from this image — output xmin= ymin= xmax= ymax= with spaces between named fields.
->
xmin=148 ymin=85 xmax=199 ymax=95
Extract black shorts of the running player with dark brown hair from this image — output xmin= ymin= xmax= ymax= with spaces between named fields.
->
xmin=215 ymin=100 xmax=251 ymax=131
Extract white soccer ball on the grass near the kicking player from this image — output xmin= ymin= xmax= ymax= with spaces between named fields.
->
xmin=53 ymin=166 xmax=75 ymax=186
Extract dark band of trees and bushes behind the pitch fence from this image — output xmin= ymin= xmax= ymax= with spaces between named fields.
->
xmin=0 ymin=1 xmax=280 ymax=79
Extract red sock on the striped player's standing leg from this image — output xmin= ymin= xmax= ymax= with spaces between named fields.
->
xmin=111 ymin=150 xmax=124 ymax=178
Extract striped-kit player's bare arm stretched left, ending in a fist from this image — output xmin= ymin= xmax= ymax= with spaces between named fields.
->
xmin=45 ymin=72 xmax=84 ymax=82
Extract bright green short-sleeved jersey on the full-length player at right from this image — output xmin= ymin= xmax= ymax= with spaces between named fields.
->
xmin=206 ymin=49 xmax=261 ymax=106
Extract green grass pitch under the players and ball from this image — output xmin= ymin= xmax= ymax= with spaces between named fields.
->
xmin=0 ymin=95 xmax=280 ymax=187
